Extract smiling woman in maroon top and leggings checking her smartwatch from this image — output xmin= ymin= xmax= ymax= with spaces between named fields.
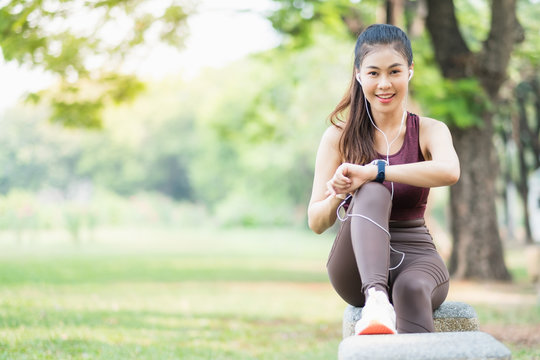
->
xmin=308 ymin=24 xmax=460 ymax=334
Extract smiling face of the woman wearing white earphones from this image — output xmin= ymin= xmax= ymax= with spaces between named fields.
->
xmin=359 ymin=45 xmax=412 ymax=113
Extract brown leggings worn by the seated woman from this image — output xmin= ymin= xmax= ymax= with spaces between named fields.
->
xmin=327 ymin=182 xmax=449 ymax=333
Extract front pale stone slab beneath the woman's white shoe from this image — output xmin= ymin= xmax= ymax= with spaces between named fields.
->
xmin=338 ymin=331 xmax=512 ymax=360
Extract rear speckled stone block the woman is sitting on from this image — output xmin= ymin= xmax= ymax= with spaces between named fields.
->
xmin=343 ymin=301 xmax=479 ymax=339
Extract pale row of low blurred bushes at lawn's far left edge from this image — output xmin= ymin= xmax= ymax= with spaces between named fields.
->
xmin=0 ymin=186 xmax=209 ymax=243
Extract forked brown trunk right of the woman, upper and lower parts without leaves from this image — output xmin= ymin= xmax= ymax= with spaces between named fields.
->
xmin=426 ymin=0 xmax=524 ymax=280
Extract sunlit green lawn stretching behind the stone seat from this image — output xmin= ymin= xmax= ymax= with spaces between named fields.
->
xmin=0 ymin=229 xmax=540 ymax=360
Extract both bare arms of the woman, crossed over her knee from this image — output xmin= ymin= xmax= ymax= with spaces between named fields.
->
xmin=308 ymin=118 xmax=460 ymax=234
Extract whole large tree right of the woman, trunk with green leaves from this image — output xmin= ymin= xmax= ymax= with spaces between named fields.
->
xmin=271 ymin=0 xmax=524 ymax=280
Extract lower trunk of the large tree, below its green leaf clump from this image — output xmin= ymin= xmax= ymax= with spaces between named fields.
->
xmin=449 ymin=119 xmax=510 ymax=280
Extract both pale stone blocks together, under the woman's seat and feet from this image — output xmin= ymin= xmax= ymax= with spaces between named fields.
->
xmin=338 ymin=301 xmax=512 ymax=360
